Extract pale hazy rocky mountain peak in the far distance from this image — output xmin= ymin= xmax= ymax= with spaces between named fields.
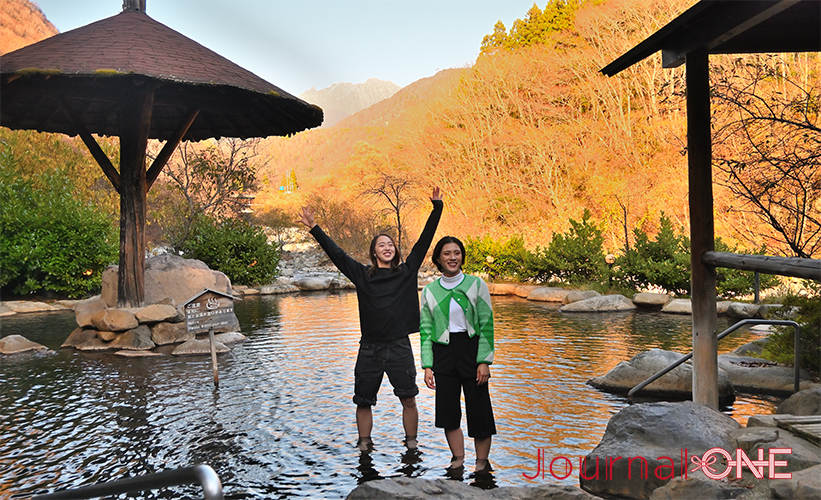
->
xmin=299 ymin=78 xmax=402 ymax=127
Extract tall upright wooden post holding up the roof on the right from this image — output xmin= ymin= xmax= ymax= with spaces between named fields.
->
xmin=686 ymin=49 xmax=718 ymax=409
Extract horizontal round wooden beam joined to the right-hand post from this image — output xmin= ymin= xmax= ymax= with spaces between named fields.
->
xmin=701 ymin=251 xmax=821 ymax=281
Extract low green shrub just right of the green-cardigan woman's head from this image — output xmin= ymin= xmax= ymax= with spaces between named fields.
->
xmin=462 ymin=236 xmax=532 ymax=281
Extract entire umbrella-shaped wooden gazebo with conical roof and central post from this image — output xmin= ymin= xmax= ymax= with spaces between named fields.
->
xmin=0 ymin=0 xmax=322 ymax=307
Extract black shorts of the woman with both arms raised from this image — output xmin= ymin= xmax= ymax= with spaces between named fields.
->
xmin=353 ymin=337 xmax=419 ymax=406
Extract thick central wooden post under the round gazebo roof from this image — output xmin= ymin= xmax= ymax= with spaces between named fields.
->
xmin=117 ymin=91 xmax=154 ymax=307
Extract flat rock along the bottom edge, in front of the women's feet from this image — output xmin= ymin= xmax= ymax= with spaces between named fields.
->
xmin=345 ymin=477 xmax=599 ymax=500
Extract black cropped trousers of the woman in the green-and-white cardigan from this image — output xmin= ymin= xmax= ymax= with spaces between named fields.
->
xmin=433 ymin=332 xmax=496 ymax=439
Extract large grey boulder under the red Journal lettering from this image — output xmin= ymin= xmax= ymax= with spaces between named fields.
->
xmin=579 ymin=401 xmax=739 ymax=499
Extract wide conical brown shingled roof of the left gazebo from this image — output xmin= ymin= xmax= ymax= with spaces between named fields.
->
xmin=0 ymin=11 xmax=322 ymax=141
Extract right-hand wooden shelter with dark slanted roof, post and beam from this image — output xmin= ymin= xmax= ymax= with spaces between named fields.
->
xmin=601 ymin=0 xmax=821 ymax=408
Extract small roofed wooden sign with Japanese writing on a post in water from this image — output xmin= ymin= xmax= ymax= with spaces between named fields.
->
xmin=183 ymin=288 xmax=234 ymax=387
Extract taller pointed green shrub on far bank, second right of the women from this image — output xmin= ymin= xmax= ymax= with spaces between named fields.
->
xmin=529 ymin=209 xmax=610 ymax=283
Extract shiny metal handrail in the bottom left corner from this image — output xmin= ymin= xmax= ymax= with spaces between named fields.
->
xmin=32 ymin=464 xmax=225 ymax=500
